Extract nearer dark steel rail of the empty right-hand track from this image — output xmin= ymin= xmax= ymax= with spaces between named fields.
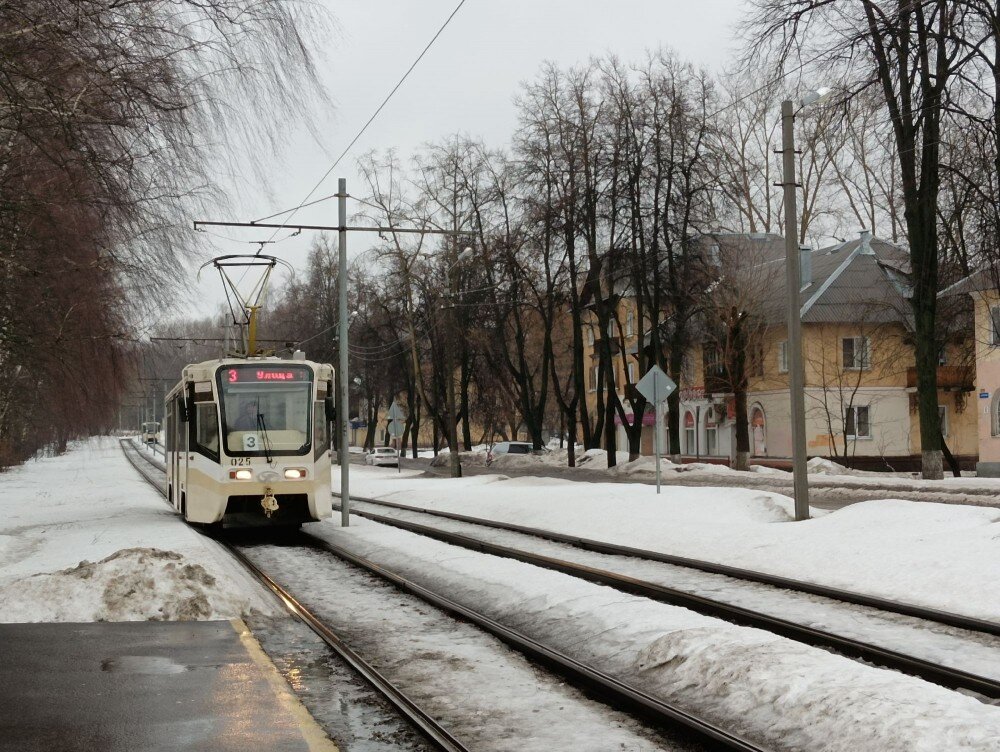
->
xmin=340 ymin=500 xmax=1000 ymax=699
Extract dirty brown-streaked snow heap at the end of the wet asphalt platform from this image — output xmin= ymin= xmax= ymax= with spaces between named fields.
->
xmin=0 ymin=548 xmax=249 ymax=622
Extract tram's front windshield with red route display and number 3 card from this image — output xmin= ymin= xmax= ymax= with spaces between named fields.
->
xmin=218 ymin=363 xmax=313 ymax=457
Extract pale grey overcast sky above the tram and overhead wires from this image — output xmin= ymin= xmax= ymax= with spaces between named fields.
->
xmin=185 ymin=0 xmax=746 ymax=315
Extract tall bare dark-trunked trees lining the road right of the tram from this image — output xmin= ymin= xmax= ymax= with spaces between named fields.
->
xmin=294 ymin=27 xmax=997 ymax=475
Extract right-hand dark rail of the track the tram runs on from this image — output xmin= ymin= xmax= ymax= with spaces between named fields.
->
xmin=301 ymin=532 xmax=766 ymax=752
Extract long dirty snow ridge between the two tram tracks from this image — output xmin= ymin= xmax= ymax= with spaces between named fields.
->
xmin=317 ymin=519 xmax=1000 ymax=752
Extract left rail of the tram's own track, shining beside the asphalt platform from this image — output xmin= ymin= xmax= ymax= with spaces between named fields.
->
xmin=122 ymin=439 xmax=470 ymax=752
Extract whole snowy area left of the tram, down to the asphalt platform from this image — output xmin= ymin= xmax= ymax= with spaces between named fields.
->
xmin=0 ymin=438 xmax=280 ymax=622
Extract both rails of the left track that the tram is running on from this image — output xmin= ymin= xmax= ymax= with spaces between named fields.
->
xmin=122 ymin=440 xmax=769 ymax=752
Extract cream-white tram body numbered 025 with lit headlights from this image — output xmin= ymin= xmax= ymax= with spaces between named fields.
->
xmin=165 ymin=353 xmax=334 ymax=527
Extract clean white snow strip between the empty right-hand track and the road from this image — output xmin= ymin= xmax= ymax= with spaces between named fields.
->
xmin=352 ymin=464 xmax=1000 ymax=621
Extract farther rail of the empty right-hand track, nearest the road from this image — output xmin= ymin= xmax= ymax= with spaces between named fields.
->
xmin=333 ymin=493 xmax=1000 ymax=637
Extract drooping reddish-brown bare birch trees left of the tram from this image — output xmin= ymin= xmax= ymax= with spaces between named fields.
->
xmin=0 ymin=0 xmax=324 ymax=467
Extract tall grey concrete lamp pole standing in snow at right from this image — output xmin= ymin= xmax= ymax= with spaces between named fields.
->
xmin=781 ymin=99 xmax=809 ymax=520
